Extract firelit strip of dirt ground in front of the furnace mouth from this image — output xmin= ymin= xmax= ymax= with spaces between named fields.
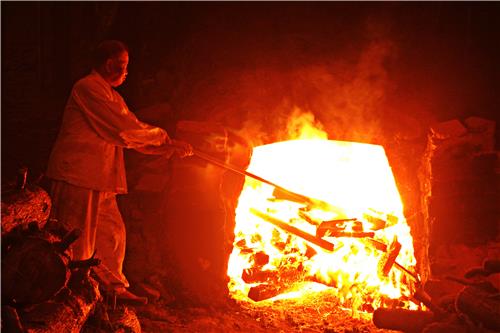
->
xmin=135 ymin=293 xmax=394 ymax=333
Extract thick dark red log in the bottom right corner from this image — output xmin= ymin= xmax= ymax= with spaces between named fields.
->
xmin=456 ymin=286 xmax=500 ymax=331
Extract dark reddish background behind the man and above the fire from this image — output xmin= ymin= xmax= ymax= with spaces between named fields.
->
xmin=1 ymin=1 xmax=500 ymax=195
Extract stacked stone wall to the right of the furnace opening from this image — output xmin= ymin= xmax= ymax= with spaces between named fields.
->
xmin=422 ymin=117 xmax=500 ymax=253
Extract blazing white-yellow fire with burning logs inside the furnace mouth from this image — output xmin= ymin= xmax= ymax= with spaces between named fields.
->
xmin=228 ymin=115 xmax=415 ymax=310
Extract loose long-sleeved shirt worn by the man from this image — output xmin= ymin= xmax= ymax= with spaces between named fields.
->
xmin=47 ymin=71 xmax=170 ymax=193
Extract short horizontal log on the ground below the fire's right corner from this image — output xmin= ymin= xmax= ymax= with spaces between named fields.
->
xmin=373 ymin=308 xmax=436 ymax=332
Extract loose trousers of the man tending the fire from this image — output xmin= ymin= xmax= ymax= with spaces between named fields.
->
xmin=51 ymin=180 xmax=129 ymax=288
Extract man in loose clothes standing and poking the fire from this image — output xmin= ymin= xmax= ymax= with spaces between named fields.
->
xmin=47 ymin=40 xmax=192 ymax=299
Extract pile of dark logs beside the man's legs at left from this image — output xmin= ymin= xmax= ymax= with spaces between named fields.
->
xmin=1 ymin=184 xmax=141 ymax=333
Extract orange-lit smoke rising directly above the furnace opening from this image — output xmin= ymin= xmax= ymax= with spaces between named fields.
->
xmin=230 ymin=36 xmax=395 ymax=145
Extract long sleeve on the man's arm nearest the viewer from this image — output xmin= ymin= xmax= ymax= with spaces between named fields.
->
xmin=72 ymin=78 xmax=169 ymax=148
